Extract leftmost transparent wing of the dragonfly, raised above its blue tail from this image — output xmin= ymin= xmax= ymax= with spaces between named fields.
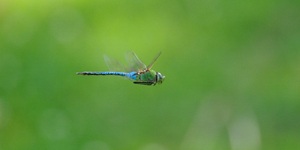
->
xmin=104 ymin=55 xmax=130 ymax=72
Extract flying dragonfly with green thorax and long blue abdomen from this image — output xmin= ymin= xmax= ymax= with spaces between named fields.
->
xmin=76 ymin=51 xmax=165 ymax=85
